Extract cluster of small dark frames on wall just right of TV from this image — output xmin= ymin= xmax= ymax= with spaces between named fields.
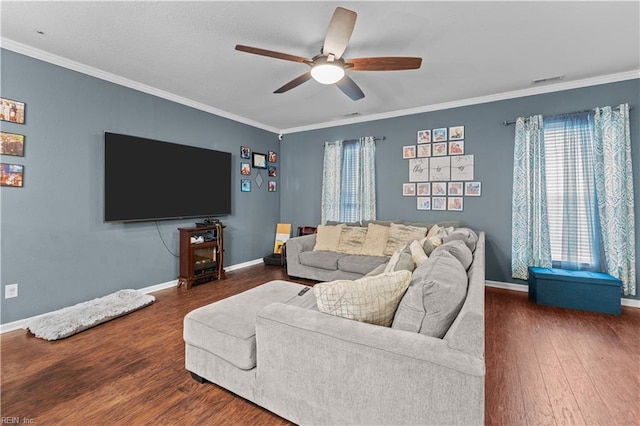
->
xmin=240 ymin=146 xmax=278 ymax=192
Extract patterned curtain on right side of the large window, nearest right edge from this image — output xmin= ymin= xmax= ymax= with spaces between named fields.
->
xmin=594 ymin=104 xmax=636 ymax=296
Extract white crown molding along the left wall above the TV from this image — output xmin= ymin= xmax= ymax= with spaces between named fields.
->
xmin=0 ymin=37 xmax=279 ymax=133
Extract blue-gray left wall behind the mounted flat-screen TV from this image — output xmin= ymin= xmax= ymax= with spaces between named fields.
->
xmin=0 ymin=50 xmax=280 ymax=323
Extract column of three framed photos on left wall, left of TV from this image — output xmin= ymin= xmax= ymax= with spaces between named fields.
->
xmin=0 ymin=98 xmax=26 ymax=188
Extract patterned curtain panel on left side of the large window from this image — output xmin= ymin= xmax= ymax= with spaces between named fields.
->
xmin=511 ymin=115 xmax=551 ymax=280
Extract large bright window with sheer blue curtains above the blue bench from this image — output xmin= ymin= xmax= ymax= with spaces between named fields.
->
xmin=544 ymin=112 xmax=600 ymax=270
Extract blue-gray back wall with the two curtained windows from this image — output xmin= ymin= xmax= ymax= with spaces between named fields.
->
xmin=280 ymin=79 xmax=640 ymax=298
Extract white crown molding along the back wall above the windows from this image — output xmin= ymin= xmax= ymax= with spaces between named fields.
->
xmin=280 ymin=70 xmax=640 ymax=134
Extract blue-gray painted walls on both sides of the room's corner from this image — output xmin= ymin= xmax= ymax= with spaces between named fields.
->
xmin=0 ymin=50 xmax=640 ymax=324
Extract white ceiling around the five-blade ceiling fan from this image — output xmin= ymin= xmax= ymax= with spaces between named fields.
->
xmin=0 ymin=0 xmax=640 ymax=133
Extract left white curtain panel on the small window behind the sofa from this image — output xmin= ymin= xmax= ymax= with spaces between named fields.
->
xmin=321 ymin=141 xmax=342 ymax=224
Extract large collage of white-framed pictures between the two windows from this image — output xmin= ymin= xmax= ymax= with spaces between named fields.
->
xmin=402 ymin=126 xmax=482 ymax=211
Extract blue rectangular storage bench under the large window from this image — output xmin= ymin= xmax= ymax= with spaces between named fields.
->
xmin=529 ymin=267 xmax=622 ymax=315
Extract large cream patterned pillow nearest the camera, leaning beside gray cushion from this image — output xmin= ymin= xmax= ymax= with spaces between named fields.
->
xmin=313 ymin=271 xmax=411 ymax=327
